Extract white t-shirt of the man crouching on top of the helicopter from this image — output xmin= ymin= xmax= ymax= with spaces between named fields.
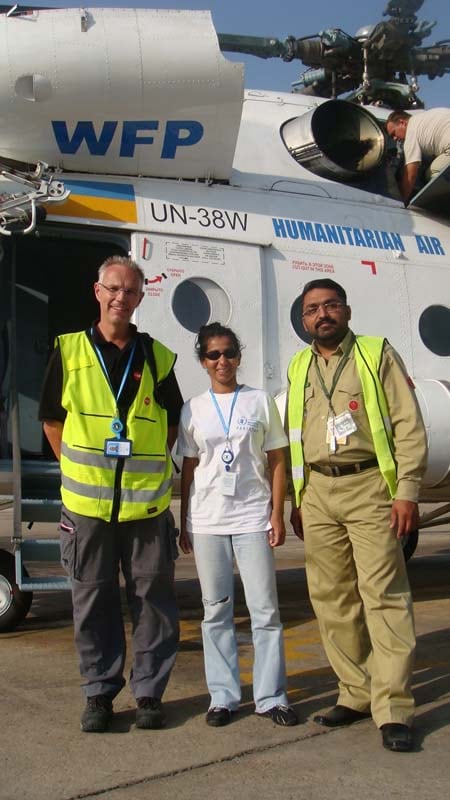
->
xmin=403 ymin=108 xmax=450 ymax=164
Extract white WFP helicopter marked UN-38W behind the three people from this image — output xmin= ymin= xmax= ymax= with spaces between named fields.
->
xmin=0 ymin=0 xmax=450 ymax=631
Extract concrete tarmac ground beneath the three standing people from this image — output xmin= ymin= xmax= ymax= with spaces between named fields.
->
xmin=0 ymin=511 xmax=450 ymax=800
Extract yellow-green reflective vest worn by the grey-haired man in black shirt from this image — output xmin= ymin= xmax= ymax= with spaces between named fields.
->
xmin=57 ymin=331 xmax=175 ymax=522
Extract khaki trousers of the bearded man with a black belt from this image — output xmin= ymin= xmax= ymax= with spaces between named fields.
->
xmin=301 ymin=468 xmax=415 ymax=727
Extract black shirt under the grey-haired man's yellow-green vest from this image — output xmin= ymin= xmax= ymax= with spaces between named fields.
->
xmin=39 ymin=323 xmax=183 ymax=426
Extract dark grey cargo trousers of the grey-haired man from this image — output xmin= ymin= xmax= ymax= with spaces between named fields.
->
xmin=60 ymin=507 xmax=179 ymax=699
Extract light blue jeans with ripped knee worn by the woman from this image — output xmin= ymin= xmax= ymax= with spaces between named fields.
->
xmin=191 ymin=531 xmax=288 ymax=713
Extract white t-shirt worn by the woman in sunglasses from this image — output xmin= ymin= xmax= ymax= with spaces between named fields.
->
xmin=177 ymin=385 xmax=288 ymax=535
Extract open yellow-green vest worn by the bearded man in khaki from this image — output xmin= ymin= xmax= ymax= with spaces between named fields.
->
xmin=288 ymin=336 xmax=397 ymax=506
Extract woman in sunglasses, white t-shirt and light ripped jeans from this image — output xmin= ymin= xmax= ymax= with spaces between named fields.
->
xmin=178 ymin=322 xmax=298 ymax=727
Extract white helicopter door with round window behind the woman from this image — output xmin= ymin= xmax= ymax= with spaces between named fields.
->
xmin=132 ymin=234 xmax=263 ymax=398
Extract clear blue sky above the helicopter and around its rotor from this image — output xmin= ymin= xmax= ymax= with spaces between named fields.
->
xmin=26 ymin=0 xmax=450 ymax=108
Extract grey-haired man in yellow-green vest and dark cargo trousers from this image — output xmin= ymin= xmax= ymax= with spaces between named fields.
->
xmin=39 ymin=256 xmax=183 ymax=733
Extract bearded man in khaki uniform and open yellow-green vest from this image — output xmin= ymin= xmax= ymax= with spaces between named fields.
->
xmin=287 ymin=278 xmax=427 ymax=751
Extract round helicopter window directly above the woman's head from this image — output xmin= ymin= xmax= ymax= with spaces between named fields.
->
xmin=172 ymin=278 xmax=231 ymax=333
